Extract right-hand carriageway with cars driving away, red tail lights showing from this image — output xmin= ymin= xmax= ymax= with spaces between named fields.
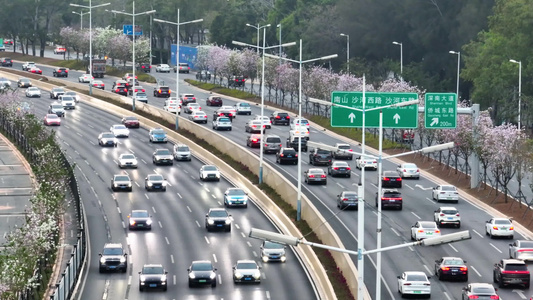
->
xmin=6 ymin=56 xmax=531 ymax=299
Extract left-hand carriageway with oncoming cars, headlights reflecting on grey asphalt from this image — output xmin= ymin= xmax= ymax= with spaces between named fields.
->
xmin=19 ymin=85 xmax=318 ymax=300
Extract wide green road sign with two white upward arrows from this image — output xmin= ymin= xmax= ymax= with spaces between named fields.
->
xmin=331 ymin=92 xmax=418 ymax=128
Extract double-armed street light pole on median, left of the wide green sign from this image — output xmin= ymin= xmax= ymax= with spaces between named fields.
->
xmin=265 ymin=45 xmax=336 ymax=221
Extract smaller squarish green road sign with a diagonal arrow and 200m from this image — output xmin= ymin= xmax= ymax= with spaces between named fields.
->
xmin=424 ymin=93 xmax=457 ymax=129
